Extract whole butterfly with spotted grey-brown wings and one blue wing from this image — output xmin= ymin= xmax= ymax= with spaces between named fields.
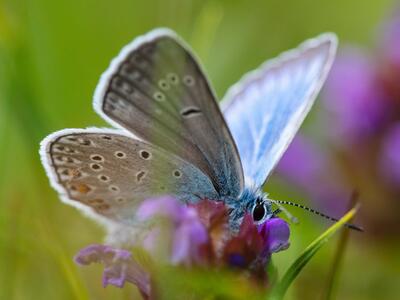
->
xmin=40 ymin=29 xmax=337 ymax=230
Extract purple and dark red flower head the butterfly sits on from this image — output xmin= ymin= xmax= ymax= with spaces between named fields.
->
xmin=75 ymin=196 xmax=289 ymax=297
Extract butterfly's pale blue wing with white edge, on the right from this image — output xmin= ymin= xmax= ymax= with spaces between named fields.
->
xmin=222 ymin=34 xmax=337 ymax=187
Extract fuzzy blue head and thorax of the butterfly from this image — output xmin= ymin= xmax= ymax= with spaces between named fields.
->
xmin=224 ymin=188 xmax=273 ymax=231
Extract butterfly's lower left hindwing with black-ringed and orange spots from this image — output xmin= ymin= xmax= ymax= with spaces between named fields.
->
xmin=42 ymin=130 xmax=217 ymax=224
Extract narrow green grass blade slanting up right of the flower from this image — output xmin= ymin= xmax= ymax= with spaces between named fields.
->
xmin=268 ymin=206 xmax=358 ymax=300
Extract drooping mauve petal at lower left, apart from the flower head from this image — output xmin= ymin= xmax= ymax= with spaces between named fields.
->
xmin=75 ymin=245 xmax=151 ymax=299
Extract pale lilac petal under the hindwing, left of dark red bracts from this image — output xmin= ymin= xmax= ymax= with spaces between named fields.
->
xmin=137 ymin=196 xmax=208 ymax=266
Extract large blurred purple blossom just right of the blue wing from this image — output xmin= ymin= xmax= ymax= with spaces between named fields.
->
xmin=323 ymin=48 xmax=389 ymax=145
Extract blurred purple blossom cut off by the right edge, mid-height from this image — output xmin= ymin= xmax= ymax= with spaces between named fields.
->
xmin=380 ymin=122 xmax=400 ymax=187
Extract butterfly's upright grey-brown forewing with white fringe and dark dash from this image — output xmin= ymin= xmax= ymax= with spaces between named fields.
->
xmin=95 ymin=31 xmax=243 ymax=200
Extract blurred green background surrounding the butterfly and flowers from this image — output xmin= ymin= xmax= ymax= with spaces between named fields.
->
xmin=0 ymin=0 xmax=400 ymax=299
